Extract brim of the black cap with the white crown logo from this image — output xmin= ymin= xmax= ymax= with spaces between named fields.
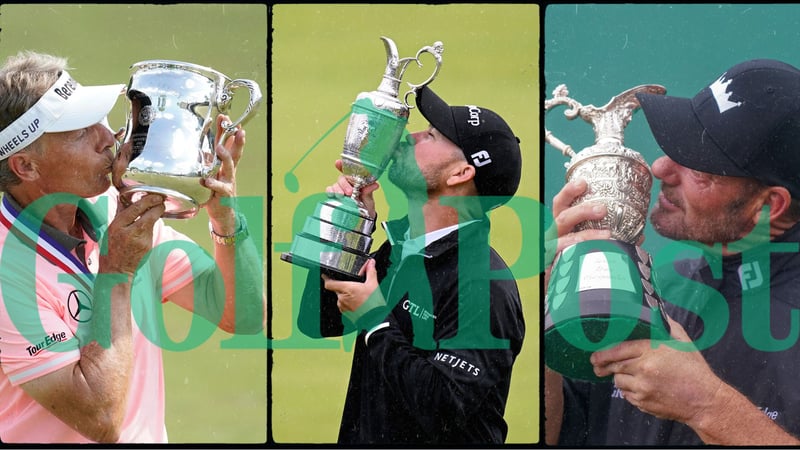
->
xmin=636 ymin=93 xmax=751 ymax=176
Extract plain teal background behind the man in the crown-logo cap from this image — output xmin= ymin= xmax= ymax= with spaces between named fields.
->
xmin=542 ymin=4 xmax=800 ymax=257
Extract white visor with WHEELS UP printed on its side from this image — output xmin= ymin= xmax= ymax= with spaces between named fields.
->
xmin=0 ymin=70 xmax=125 ymax=160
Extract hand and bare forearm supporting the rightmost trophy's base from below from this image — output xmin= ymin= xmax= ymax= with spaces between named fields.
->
xmin=591 ymin=319 xmax=800 ymax=446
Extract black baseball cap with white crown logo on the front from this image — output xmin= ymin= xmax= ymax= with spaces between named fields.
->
xmin=636 ymin=59 xmax=800 ymax=198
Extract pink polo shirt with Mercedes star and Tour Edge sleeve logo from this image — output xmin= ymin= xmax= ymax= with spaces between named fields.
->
xmin=0 ymin=187 xmax=214 ymax=443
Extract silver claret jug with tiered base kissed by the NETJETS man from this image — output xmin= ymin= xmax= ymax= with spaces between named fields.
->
xmin=281 ymin=37 xmax=443 ymax=280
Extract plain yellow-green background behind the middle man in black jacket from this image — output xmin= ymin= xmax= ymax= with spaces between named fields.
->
xmin=270 ymin=4 xmax=541 ymax=443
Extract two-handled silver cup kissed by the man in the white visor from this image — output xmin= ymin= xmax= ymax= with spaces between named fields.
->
xmin=112 ymin=60 xmax=261 ymax=219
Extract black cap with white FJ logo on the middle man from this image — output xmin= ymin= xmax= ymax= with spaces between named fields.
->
xmin=416 ymin=86 xmax=522 ymax=211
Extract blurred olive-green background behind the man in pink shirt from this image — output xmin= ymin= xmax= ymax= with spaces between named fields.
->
xmin=0 ymin=4 xmax=268 ymax=443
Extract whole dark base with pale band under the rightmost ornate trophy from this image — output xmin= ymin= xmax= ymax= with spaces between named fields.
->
xmin=544 ymin=239 xmax=670 ymax=381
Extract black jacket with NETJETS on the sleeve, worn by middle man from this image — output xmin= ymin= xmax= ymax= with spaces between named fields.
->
xmin=298 ymin=219 xmax=525 ymax=445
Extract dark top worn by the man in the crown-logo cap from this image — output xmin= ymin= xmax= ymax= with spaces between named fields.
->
xmin=560 ymin=220 xmax=800 ymax=447
